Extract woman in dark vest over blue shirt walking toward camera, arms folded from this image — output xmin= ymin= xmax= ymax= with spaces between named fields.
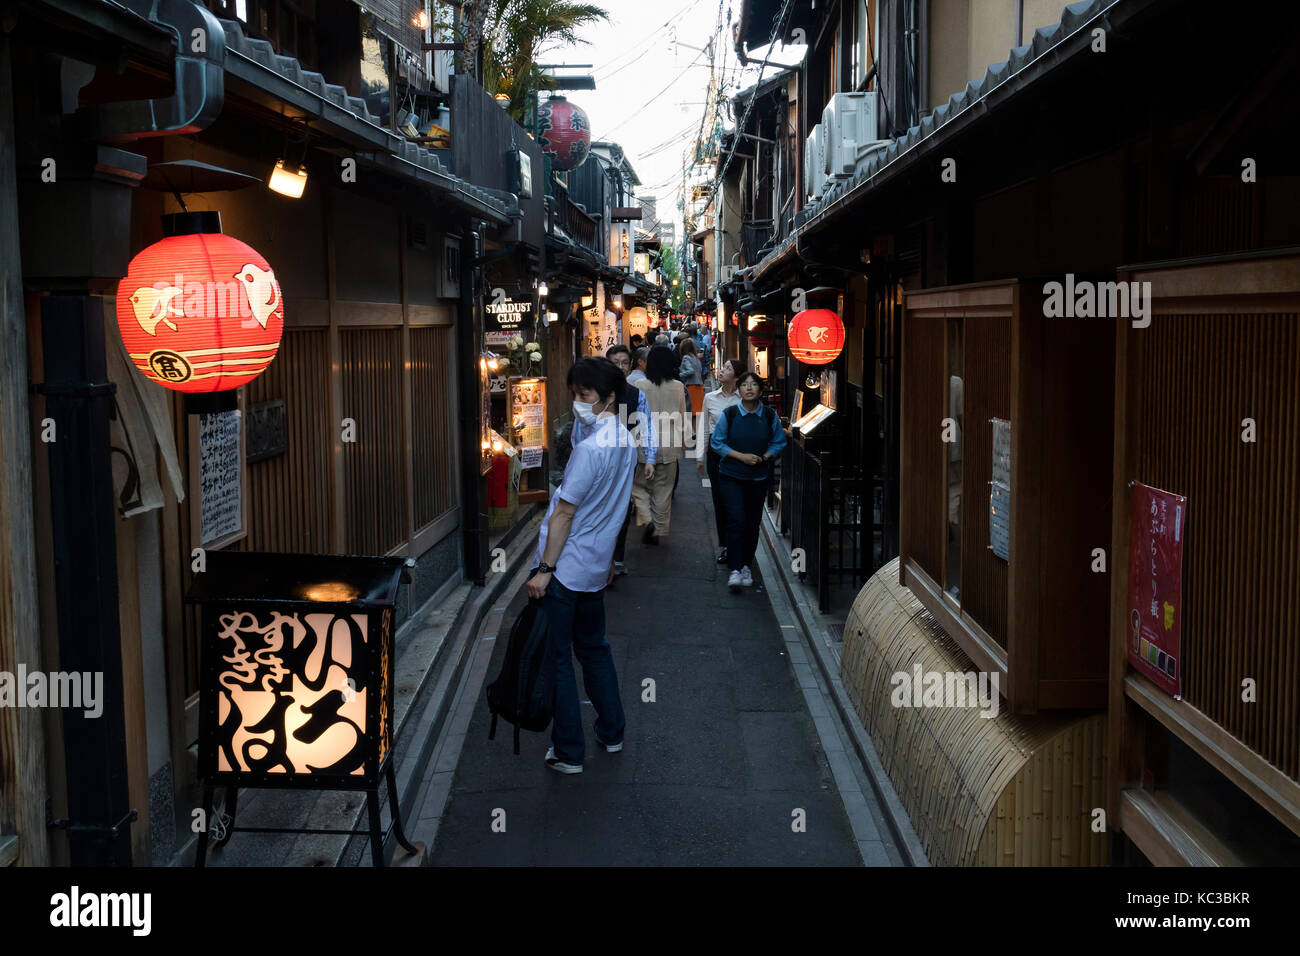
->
xmin=711 ymin=372 xmax=785 ymax=591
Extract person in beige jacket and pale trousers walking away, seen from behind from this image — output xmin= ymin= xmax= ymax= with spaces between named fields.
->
xmin=632 ymin=347 xmax=690 ymax=545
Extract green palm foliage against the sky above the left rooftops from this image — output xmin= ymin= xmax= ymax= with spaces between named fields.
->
xmin=481 ymin=0 xmax=610 ymax=122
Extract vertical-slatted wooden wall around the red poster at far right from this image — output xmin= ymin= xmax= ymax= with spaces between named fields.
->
xmin=1127 ymin=313 xmax=1300 ymax=779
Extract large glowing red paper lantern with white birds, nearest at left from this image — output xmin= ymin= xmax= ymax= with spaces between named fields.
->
xmin=117 ymin=233 xmax=285 ymax=392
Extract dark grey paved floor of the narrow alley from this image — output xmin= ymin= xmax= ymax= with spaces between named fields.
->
xmin=433 ymin=460 xmax=861 ymax=866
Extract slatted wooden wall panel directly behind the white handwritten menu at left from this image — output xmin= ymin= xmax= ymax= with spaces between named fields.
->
xmin=238 ymin=329 xmax=332 ymax=554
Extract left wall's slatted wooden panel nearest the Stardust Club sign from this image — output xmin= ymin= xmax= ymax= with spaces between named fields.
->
xmin=411 ymin=326 xmax=456 ymax=531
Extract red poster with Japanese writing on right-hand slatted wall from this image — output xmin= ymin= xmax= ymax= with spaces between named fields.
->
xmin=1128 ymin=481 xmax=1187 ymax=697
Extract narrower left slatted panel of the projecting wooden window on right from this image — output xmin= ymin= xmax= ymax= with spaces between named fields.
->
xmin=900 ymin=316 xmax=948 ymax=581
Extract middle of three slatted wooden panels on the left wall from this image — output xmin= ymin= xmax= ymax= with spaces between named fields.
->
xmin=339 ymin=329 xmax=407 ymax=554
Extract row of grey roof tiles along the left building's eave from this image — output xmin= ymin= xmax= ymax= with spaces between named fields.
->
xmin=218 ymin=20 xmax=506 ymax=216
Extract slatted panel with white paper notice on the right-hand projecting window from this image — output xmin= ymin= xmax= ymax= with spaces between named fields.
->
xmin=961 ymin=315 xmax=1015 ymax=648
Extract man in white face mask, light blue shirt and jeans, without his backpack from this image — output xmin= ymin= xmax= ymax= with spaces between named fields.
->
xmin=528 ymin=358 xmax=637 ymax=774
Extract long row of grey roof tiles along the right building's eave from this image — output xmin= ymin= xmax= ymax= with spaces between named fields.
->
xmin=749 ymin=0 xmax=1126 ymax=282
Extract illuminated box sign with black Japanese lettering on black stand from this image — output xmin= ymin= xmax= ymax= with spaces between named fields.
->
xmin=187 ymin=551 xmax=408 ymax=862
